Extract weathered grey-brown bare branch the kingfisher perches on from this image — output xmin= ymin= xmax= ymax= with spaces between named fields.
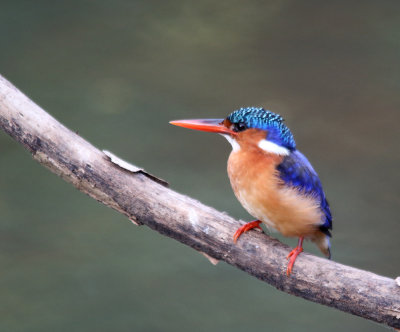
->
xmin=0 ymin=76 xmax=400 ymax=328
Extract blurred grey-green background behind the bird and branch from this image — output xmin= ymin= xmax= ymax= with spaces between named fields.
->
xmin=0 ymin=0 xmax=400 ymax=332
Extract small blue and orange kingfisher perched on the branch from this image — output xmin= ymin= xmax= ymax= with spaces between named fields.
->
xmin=170 ymin=107 xmax=332 ymax=276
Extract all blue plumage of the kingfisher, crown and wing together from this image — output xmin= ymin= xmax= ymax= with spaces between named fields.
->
xmin=227 ymin=107 xmax=332 ymax=236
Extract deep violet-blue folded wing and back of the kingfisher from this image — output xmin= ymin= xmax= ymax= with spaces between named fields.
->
xmin=277 ymin=150 xmax=332 ymax=236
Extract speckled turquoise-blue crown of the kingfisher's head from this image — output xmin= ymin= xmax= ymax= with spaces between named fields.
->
xmin=227 ymin=107 xmax=296 ymax=151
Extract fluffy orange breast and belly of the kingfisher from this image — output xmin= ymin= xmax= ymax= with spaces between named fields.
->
xmin=228 ymin=148 xmax=322 ymax=237
